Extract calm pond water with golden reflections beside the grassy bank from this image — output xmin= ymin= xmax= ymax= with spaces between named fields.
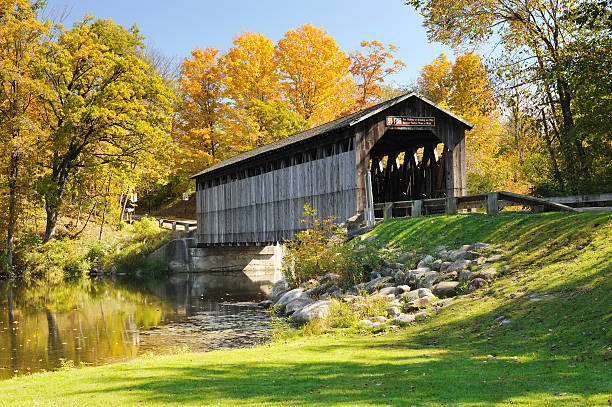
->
xmin=0 ymin=274 xmax=269 ymax=379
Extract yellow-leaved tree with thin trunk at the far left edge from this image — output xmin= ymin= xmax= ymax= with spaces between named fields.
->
xmin=0 ymin=0 xmax=48 ymax=269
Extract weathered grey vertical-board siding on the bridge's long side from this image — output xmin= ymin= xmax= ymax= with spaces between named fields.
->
xmin=197 ymin=150 xmax=357 ymax=244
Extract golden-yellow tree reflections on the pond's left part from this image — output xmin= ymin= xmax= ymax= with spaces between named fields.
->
xmin=0 ymin=279 xmax=171 ymax=378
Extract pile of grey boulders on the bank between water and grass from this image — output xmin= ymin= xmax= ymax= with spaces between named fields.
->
xmin=260 ymin=243 xmax=507 ymax=328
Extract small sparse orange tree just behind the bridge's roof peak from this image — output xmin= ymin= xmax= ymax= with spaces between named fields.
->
xmin=351 ymin=41 xmax=406 ymax=108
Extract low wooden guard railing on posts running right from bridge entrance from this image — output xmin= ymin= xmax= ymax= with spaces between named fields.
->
xmin=374 ymin=191 xmax=577 ymax=219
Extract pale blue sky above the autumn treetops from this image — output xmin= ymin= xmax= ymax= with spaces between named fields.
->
xmin=47 ymin=0 xmax=453 ymax=85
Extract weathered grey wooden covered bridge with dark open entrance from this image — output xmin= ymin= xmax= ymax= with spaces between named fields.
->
xmin=193 ymin=94 xmax=472 ymax=246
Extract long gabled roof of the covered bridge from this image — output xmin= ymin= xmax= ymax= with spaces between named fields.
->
xmin=191 ymin=93 xmax=473 ymax=178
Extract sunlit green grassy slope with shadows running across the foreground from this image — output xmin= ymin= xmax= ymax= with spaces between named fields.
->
xmin=0 ymin=214 xmax=612 ymax=407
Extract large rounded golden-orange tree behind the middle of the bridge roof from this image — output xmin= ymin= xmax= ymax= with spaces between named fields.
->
xmin=275 ymin=24 xmax=356 ymax=125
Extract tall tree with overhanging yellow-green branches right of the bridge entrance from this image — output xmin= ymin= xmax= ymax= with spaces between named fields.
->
xmin=407 ymin=0 xmax=612 ymax=193
